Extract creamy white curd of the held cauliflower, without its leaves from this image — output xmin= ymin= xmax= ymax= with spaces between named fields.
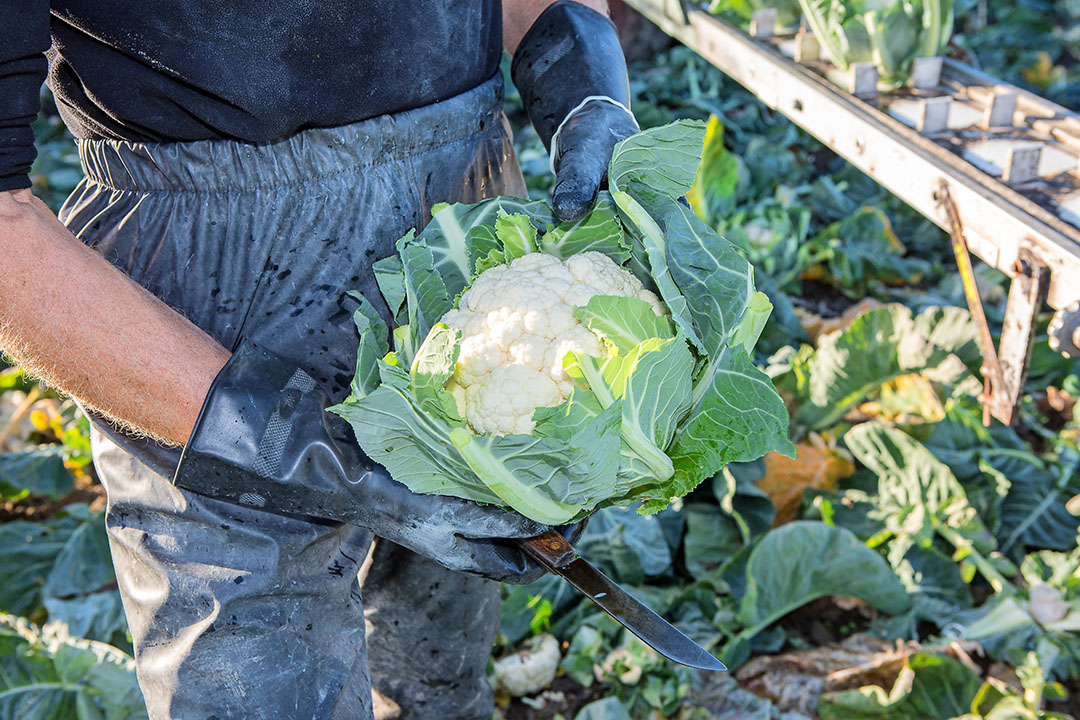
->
xmin=442 ymin=252 xmax=665 ymax=435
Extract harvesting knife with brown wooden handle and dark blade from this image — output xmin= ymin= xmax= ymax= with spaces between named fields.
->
xmin=517 ymin=530 xmax=728 ymax=670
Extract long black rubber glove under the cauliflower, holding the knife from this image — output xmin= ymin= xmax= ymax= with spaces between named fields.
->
xmin=174 ymin=342 xmax=548 ymax=584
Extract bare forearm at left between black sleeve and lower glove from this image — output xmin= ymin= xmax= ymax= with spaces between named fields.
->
xmin=0 ymin=190 xmax=229 ymax=445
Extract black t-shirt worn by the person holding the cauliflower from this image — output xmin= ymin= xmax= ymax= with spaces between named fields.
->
xmin=0 ymin=0 xmax=502 ymax=190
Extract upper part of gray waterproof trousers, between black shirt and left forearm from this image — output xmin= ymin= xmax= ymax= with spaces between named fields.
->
xmin=59 ymin=76 xmax=525 ymax=474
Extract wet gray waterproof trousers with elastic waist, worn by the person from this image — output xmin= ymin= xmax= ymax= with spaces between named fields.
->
xmin=60 ymin=78 xmax=525 ymax=720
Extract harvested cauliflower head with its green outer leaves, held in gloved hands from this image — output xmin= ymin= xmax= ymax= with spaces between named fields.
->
xmin=332 ymin=121 xmax=795 ymax=525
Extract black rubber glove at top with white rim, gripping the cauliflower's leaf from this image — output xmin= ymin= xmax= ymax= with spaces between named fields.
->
xmin=510 ymin=0 xmax=638 ymax=220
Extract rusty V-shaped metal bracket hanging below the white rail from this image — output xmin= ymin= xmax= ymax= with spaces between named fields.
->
xmin=935 ymin=180 xmax=1050 ymax=426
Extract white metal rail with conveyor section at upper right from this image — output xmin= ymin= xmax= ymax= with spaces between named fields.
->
xmin=624 ymin=0 xmax=1080 ymax=309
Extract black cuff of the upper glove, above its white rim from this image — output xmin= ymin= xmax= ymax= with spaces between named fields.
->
xmin=510 ymin=0 xmax=633 ymax=150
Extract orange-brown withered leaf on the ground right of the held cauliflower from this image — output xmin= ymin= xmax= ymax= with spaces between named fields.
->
xmin=757 ymin=443 xmax=855 ymax=527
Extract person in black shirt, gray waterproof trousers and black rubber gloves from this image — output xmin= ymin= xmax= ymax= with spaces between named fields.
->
xmin=0 ymin=0 xmax=636 ymax=720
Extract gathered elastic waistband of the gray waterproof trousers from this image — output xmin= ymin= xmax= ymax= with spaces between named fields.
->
xmin=78 ymin=73 xmax=502 ymax=192
